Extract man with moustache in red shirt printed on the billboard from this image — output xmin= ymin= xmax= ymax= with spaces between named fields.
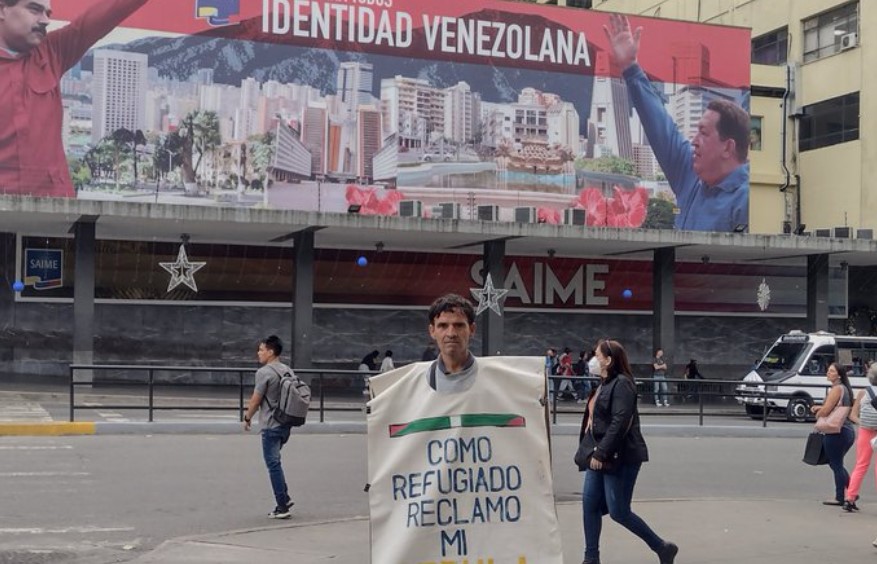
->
xmin=0 ymin=0 xmax=149 ymax=197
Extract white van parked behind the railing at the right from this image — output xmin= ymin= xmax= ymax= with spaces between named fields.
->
xmin=735 ymin=331 xmax=877 ymax=421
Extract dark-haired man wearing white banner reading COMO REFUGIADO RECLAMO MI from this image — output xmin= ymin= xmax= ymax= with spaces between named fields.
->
xmin=368 ymin=294 xmax=563 ymax=564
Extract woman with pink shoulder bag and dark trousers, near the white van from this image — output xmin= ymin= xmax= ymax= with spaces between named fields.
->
xmin=810 ymin=362 xmax=856 ymax=506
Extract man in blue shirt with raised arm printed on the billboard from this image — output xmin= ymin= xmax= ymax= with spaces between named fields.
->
xmin=603 ymin=14 xmax=749 ymax=232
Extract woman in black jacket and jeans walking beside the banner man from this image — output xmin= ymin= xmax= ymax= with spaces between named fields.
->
xmin=576 ymin=340 xmax=679 ymax=564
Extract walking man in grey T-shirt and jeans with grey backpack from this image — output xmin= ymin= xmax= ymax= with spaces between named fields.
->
xmin=244 ymin=335 xmax=302 ymax=519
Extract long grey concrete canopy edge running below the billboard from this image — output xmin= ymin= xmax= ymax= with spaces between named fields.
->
xmin=0 ymin=196 xmax=877 ymax=266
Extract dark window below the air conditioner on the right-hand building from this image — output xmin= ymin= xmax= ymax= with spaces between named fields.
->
xmin=798 ymin=92 xmax=859 ymax=151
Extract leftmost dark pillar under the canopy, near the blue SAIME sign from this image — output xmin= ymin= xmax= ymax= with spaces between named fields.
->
xmin=73 ymin=220 xmax=96 ymax=382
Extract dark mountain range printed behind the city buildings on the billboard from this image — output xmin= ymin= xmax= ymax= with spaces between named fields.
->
xmin=82 ymin=8 xmax=592 ymax=111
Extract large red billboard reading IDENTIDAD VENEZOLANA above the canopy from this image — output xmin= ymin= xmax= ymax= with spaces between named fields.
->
xmin=0 ymin=0 xmax=750 ymax=231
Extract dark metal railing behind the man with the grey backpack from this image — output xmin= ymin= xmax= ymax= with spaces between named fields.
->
xmin=69 ymin=364 xmax=377 ymax=423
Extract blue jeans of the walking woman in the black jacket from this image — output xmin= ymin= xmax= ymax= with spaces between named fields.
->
xmin=582 ymin=462 xmax=664 ymax=560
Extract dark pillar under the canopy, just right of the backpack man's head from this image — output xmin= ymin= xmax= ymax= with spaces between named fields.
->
xmin=290 ymin=229 xmax=314 ymax=368
